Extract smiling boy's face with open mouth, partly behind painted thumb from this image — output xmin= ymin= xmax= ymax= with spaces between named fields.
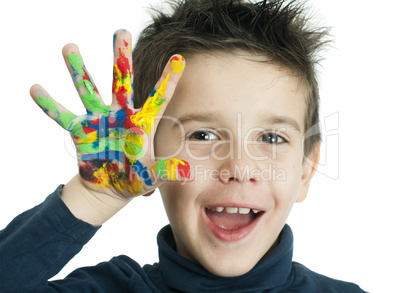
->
xmin=155 ymin=54 xmax=318 ymax=276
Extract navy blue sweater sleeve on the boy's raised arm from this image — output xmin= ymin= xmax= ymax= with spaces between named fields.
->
xmin=0 ymin=185 xmax=99 ymax=293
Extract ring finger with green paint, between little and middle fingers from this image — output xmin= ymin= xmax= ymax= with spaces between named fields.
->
xmin=63 ymin=44 xmax=110 ymax=116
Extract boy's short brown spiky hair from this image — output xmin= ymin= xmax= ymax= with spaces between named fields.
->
xmin=133 ymin=0 xmax=328 ymax=156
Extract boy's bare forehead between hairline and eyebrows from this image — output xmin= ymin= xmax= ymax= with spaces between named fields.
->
xmin=165 ymin=52 xmax=306 ymax=128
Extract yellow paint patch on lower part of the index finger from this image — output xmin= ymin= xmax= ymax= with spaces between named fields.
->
xmin=130 ymin=73 xmax=170 ymax=134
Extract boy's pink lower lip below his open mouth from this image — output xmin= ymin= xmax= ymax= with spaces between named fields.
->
xmin=202 ymin=208 xmax=262 ymax=242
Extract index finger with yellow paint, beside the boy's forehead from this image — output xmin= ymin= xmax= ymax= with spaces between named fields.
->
xmin=131 ymin=55 xmax=185 ymax=134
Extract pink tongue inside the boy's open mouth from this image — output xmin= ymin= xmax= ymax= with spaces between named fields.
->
xmin=205 ymin=209 xmax=255 ymax=230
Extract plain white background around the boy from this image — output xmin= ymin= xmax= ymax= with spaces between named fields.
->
xmin=0 ymin=0 xmax=402 ymax=292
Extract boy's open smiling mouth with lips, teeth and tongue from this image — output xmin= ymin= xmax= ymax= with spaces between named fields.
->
xmin=202 ymin=206 xmax=264 ymax=242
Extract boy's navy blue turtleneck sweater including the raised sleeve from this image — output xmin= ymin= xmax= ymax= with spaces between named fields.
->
xmin=0 ymin=186 xmax=364 ymax=293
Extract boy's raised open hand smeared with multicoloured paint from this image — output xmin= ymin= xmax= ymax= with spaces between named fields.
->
xmin=31 ymin=30 xmax=190 ymax=198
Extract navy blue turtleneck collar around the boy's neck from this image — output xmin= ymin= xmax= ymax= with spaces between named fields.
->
xmin=158 ymin=225 xmax=293 ymax=293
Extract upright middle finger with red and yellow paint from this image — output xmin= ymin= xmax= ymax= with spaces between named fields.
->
xmin=111 ymin=30 xmax=134 ymax=110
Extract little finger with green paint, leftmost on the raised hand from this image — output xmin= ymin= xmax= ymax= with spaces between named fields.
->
xmin=30 ymin=84 xmax=77 ymax=130
